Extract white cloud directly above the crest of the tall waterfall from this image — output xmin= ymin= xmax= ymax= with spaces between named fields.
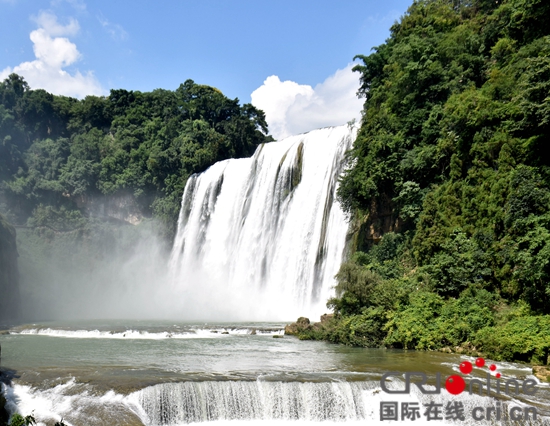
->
xmin=251 ymin=64 xmax=363 ymax=139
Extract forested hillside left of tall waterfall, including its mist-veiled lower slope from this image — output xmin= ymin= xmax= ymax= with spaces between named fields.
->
xmin=0 ymin=74 xmax=272 ymax=321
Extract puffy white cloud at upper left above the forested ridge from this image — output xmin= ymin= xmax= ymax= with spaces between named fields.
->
xmin=0 ymin=12 xmax=105 ymax=98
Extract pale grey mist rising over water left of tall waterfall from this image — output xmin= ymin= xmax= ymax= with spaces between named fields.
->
xmin=18 ymin=222 xmax=172 ymax=321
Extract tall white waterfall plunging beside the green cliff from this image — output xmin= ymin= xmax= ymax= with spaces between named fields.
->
xmin=170 ymin=126 xmax=355 ymax=320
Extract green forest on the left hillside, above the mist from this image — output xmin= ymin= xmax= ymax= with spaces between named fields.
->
xmin=0 ymin=78 xmax=271 ymax=234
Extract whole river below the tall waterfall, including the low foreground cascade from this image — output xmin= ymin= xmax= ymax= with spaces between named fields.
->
xmin=0 ymin=321 xmax=550 ymax=425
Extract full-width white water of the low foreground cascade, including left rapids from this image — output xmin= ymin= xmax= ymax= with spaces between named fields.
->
xmin=2 ymin=379 xmax=547 ymax=426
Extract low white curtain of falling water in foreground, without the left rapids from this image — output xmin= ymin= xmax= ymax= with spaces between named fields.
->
xmin=127 ymin=380 xmax=516 ymax=426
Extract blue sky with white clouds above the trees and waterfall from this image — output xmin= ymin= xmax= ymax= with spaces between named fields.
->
xmin=0 ymin=0 xmax=412 ymax=139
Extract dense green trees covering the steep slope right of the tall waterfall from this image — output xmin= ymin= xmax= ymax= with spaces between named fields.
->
xmin=300 ymin=0 xmax=550 ymax=364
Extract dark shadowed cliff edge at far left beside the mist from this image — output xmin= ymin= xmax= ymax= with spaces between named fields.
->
xmin=0 ymin=215 xmax=20 ymax=322
